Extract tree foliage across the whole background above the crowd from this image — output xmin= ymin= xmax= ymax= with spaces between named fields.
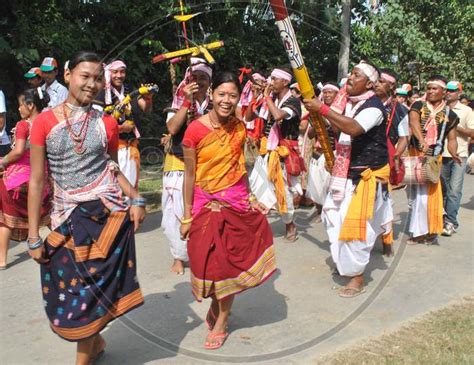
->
xmin=0 ymin=0 xmax=474 ymax=136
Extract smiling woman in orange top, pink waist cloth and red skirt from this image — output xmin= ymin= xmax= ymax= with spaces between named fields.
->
xmin=181 ymin=72 xmax=276 ymax=349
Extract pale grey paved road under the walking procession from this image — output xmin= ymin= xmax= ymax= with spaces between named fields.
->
xmin=0 ymin=176 xmax=474 ymax=365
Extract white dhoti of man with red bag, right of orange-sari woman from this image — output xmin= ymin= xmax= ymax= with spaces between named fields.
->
xmin=249 ymin=154 xmax=294 ymax=224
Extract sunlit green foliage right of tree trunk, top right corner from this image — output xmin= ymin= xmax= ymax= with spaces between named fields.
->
xmin=353 ymin=0 xmax=474 ymax=90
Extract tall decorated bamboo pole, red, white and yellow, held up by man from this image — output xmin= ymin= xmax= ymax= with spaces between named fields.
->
xmin=270 ymin=0 xmax=334 ymax=170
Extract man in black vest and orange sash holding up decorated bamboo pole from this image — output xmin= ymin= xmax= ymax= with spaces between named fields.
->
xmin=304 ymin=61 xmax=393 ymax=298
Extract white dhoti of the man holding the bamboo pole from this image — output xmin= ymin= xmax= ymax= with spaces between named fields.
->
xmin=321 ymin=180 xmax=393 ymax=277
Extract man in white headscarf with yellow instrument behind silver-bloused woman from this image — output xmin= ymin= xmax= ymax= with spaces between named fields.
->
xmin=94 ymin=60 xmax=153 ymax=188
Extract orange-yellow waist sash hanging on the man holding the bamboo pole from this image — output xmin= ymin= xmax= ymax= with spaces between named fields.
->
xmin=339 ymin=164 xmax=390 ymax=241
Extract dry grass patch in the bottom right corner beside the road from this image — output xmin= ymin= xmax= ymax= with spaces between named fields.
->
xmin=318 ymin=297 xmax=474 ymax=365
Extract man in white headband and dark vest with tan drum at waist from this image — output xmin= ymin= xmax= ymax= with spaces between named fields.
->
xmin=407 ymin=75 xmax=461 ymax=245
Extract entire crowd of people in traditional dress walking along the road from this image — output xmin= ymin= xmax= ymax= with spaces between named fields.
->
xmin=0 ymin=52 xmax=474 ymax=364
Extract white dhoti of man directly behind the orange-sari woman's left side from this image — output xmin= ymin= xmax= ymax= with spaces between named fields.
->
xmin=161 ymin=171 xmax=188 ymax=261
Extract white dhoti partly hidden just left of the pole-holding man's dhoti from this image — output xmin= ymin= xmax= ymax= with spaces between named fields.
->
xmin=306 ymin=155 xmax=331 ymax=205
